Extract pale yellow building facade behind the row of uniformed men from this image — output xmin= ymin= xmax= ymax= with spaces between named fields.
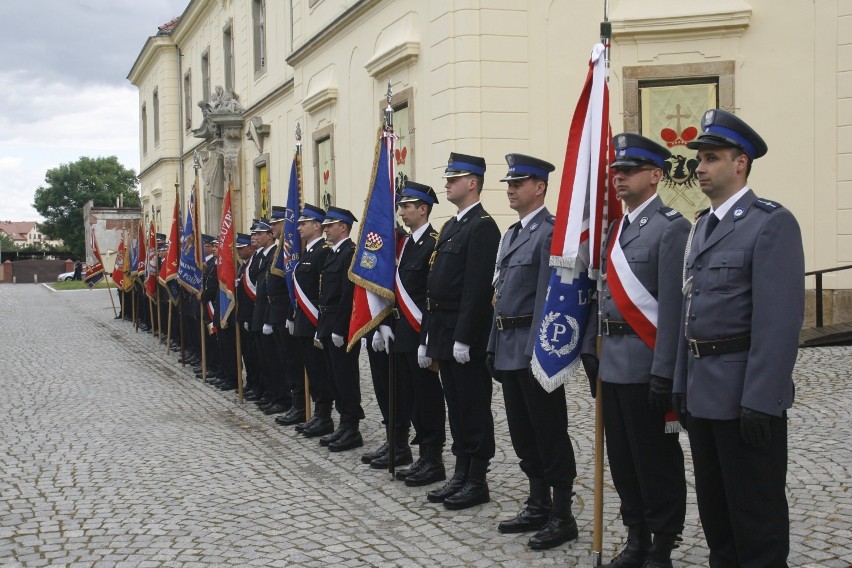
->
xmin=128 ymin=0 xmax=852 ymax=321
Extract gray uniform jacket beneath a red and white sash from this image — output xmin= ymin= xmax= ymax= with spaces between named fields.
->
xmin=583 ymin=195 xmax=691 ymax=384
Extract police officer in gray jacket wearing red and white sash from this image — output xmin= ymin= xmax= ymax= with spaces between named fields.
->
xmin=582 ymin=133 xmax=690 ymax=568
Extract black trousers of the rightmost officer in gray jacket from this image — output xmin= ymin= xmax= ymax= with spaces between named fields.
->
xmin=687 ymin=414 xmax=790 ymax=568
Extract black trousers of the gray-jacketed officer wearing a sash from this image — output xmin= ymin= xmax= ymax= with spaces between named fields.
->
xmin=603 ymin=381 xmax=686 ymax=535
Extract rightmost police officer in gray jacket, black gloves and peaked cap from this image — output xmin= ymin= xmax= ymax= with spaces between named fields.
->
xmin=674 ymin=109 xmax=804 ymax=566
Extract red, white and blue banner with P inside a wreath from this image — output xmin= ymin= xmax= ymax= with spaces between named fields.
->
xmin=532 ymin=44 xmax=620 ymax=392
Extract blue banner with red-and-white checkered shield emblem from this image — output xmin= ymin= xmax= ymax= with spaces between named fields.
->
xmin=349 ymin=129 xmax=396 ymax=349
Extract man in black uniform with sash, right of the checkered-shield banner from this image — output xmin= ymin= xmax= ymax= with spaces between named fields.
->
xmin=370 ymin=180 xmax=447 ymax=487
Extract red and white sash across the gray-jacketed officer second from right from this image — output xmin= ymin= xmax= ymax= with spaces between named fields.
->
xmin=606 ymin=220 xmax=658 ymax=349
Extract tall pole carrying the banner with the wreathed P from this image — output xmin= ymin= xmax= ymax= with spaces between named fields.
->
xmin=592 ymin=0 xmax=612 ymax=566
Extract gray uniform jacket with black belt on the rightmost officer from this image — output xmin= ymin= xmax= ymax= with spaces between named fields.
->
xmin=674 ymin=190 xmax=805 ymax=420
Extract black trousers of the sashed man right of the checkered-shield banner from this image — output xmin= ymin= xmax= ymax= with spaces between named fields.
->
xmin=393 ymin=351 xmax=447 ymax=452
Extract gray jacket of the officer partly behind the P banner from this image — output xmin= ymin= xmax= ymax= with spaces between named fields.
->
xmin=488 ymin=208 xmax=554 ymax=371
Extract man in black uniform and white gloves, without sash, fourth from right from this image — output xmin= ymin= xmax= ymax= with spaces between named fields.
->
xmin=418 ymin=153 xmax=500 ymax=510
